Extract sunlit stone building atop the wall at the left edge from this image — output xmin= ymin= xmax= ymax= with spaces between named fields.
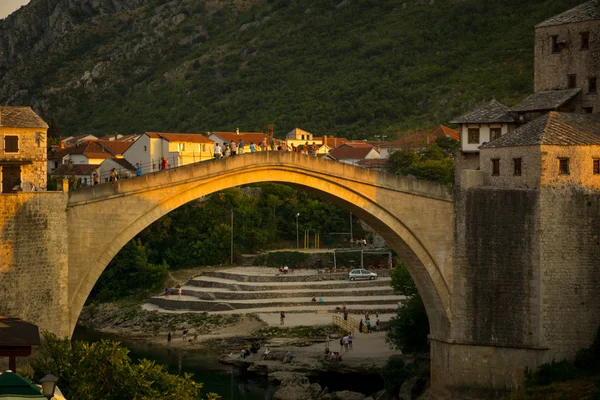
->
xmin=0 ymin=106 xmax=48 ymax=193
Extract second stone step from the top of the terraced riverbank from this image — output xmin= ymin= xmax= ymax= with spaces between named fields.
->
xmin=188 ymin=275 xmax=391 ymax=291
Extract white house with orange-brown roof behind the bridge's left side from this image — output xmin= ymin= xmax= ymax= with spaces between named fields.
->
xmin=123 ymin=132 xmax=214 ymax=174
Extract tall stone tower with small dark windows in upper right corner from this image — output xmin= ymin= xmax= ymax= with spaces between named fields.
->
xmin=534 ymin=0 xmax=600 ymax=113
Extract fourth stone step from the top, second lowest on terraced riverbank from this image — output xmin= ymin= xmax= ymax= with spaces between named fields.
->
xmin=149 ymin=295 xmax=406 ymax=311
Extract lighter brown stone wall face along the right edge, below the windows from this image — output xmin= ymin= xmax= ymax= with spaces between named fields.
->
xmin=540 ymin=187 xmax=600 ymax=361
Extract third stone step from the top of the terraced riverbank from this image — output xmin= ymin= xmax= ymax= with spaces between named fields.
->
xmin=181 ymin=286 xmax=394 ymax=300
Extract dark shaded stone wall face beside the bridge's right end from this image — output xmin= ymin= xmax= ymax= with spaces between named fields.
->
xmin=452 ymin=187 xmax=539 ymax=346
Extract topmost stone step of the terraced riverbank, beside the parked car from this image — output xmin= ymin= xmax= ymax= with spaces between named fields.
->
xmin=202 ymin=268 xmax=390 ymax=282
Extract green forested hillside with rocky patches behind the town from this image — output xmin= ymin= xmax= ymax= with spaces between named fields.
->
xmin=0 ymin=0 xmax=583 ymax=138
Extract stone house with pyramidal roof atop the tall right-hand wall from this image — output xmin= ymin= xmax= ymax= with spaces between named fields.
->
xmin=480 ymin=111 xmax=600 ymax=190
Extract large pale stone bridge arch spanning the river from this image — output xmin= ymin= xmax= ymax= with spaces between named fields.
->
xmin=67 ymin=152 xmax=453 ymax=337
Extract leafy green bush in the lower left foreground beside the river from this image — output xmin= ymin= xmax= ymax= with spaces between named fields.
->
xmin=31 ymin=333 xmax=219 ymax=400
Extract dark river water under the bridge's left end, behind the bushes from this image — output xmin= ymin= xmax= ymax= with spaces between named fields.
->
xmin=73 ymin=327 xmax=277 ymax=400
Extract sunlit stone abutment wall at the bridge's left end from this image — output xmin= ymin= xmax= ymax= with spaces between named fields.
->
xmin=0 ymin=192 xmax=69 ymax=336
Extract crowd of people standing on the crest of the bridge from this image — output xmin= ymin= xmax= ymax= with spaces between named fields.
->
xmin=214 ymin=138 xmax=319 ymax=159
